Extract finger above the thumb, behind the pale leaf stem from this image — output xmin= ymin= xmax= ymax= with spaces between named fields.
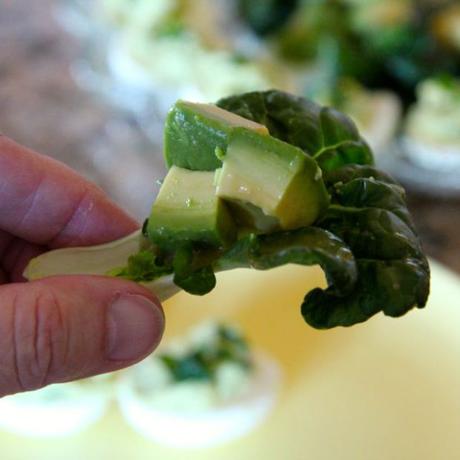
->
xmin=0 ymin=135 xmax=138 ymax=247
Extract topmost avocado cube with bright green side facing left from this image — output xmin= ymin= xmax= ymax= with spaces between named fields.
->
xmin=164 ymin=101 xmax=268 ymax=171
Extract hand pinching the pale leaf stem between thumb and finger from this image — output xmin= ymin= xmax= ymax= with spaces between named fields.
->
xmin=0 ymin=135 xmax=164 ymax=397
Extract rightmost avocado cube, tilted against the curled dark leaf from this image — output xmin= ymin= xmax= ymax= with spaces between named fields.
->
xmin=216 ymin=128 xmax=329 ymax=229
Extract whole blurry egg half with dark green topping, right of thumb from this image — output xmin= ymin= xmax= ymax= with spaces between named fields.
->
xmin=118 ymin=322 xmax=280 ymax=448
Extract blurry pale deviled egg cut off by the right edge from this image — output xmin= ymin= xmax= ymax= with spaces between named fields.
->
xmin=401 ymin=76 xmax=460 ymax=172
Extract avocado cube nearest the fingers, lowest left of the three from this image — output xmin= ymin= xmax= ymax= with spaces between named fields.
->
xmin=147 ymin=166 xmax=236 ymax=250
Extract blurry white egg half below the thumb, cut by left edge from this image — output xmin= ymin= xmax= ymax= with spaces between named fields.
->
xmin=0 ymin=374 xmax=114 ymax=437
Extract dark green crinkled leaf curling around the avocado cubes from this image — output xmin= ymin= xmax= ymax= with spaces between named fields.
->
xmin=117 ymin=91 xmax=429 ymax=328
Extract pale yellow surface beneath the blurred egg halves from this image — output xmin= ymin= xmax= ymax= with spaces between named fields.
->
xmin=0 ymin=262 xmax=460 ymax=460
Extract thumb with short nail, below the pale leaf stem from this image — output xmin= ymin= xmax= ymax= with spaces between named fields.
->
xmin=0 ymin=276 xmax=164 ymax=397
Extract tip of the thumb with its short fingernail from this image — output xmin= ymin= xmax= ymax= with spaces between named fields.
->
xmin=107 ymin=294 xmax=164 ymax=361
